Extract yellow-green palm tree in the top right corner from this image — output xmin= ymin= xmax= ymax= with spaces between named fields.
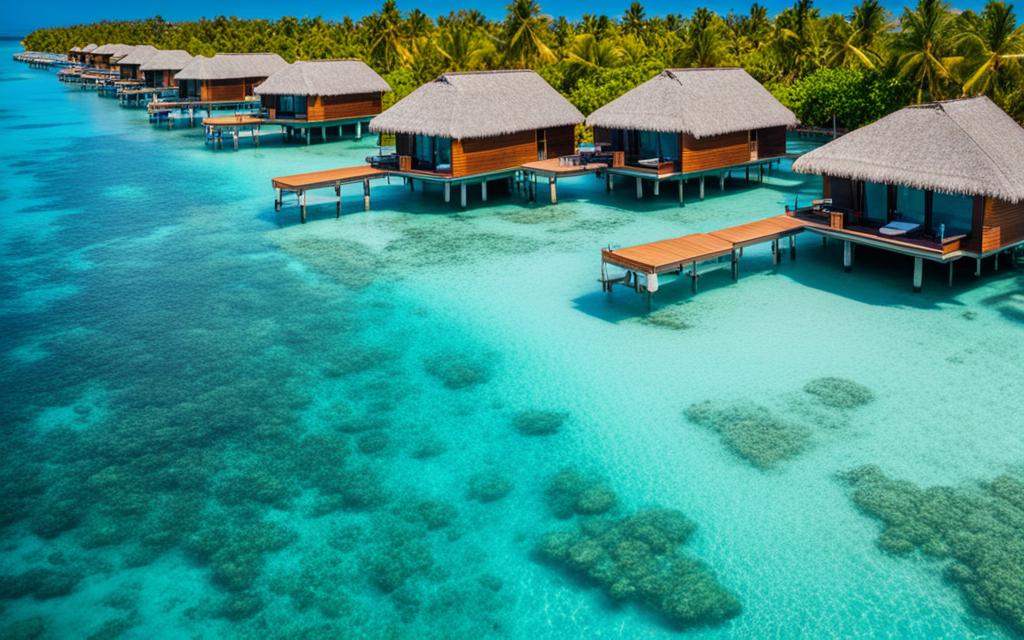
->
xmin=957 ymin=0 xmax=1024 ymax=95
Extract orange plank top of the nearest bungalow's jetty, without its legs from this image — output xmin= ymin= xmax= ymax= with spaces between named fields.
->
xmin=601 ymin=215 xmax=806 ymax=273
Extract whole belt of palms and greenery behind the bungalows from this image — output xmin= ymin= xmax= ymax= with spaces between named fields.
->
xmin=24 ymin=0 xmax=1024 ymax=128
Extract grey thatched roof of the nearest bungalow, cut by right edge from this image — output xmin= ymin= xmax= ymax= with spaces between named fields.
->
xmin=793 ymin=97 xmax=1024 ymax=203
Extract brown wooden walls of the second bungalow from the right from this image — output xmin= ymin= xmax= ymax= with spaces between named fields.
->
xmin=594 ymin=126 xmax=785 ymax=173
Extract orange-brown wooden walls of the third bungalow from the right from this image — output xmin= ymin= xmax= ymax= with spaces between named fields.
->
xmin=395 ymin=125 xmax=575 ymax=178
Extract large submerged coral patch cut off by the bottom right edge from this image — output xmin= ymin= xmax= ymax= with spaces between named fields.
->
xmin=842 ymin=465 xmax=1024 ymax=633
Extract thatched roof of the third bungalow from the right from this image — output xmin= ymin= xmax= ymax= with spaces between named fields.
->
xmin=370 ymin=71 xmax=584 ymax=139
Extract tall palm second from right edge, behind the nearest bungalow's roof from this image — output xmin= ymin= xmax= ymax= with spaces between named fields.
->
xmin=893 ymin=0 xmax=959 ymax=103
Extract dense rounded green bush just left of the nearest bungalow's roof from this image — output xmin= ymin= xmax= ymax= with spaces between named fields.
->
xmin=773 ymin=69 xmax=912 ymax=129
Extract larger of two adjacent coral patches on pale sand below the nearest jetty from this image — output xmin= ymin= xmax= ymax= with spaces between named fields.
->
xmin=686 ymin=400 xmax=811 ymax=469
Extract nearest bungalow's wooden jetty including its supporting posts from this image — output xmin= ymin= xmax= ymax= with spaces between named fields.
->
xmin=601 ymin=215 xmax=808 ymax=294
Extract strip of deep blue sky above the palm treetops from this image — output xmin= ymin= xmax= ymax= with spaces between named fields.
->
xmin=0 ymin=0 xmax=984 ymax=36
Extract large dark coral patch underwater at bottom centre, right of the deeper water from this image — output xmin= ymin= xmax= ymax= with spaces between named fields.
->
xmin=537 ymin=509 xmax=740 ymax=628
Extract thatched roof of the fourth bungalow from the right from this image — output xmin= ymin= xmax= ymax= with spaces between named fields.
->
xmin=255 ymin=60 xmax=391 ymax=95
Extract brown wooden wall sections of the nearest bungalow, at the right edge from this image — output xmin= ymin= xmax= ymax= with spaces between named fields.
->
xmin=821 ymin=176 xmax=1024 ymax=253
